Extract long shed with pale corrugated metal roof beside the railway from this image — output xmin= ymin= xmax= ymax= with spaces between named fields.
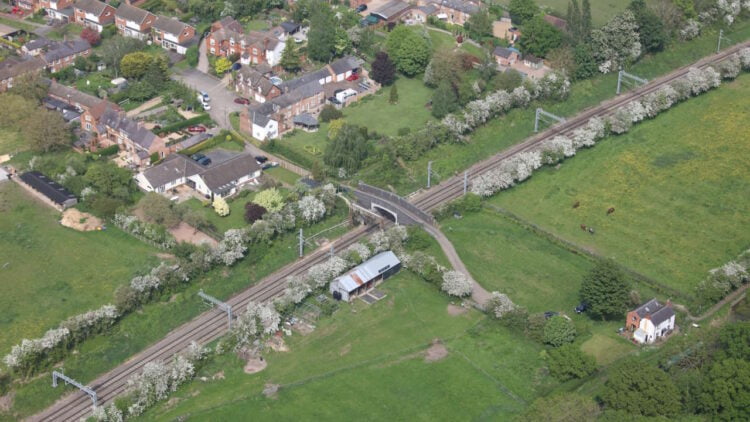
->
xmin=330 ymin=251 xmax=401 ymax=302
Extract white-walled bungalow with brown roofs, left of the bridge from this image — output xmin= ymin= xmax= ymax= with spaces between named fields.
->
xmin=135 ymin=153 xmax=261 ymax=199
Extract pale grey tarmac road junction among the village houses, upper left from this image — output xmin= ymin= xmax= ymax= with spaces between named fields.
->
xmin=172 ymin=69 xmax=245 ymax=129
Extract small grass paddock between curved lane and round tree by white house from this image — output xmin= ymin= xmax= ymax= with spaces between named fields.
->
xmin=440 ymin=209 xmax=593 ymax=312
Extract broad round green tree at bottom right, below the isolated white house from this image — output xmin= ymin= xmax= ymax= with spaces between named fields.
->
xmin=602 ymin=357 xmax=680 ymax=417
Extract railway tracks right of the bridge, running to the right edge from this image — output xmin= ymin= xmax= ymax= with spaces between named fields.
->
xmin=410 ymin=42 xmax=750 ymax=211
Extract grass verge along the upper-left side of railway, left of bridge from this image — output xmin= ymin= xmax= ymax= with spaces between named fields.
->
xmin=0 ymin=199 xmax=349 ymax=420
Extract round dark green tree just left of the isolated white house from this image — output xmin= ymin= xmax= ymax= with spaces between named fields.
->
xmin=581 ymin=260 xmax=630 ymax=319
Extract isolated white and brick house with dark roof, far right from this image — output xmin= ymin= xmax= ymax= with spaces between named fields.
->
xmin=625 ymin=299 xmax=675 ymax=344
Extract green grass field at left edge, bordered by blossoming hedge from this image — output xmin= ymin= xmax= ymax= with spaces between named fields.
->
xmin=0 ymin=182 xmax=157 ymax=355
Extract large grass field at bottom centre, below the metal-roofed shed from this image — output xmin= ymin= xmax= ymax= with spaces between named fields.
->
xmin=144 ymin=270 xmax=542 ymax=421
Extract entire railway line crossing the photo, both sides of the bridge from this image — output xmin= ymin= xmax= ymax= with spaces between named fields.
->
xmin=29 ymin=42 xmax=750 ymax=421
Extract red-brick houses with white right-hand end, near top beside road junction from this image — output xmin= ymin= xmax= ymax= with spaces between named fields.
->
xmin=205 ymin=16 xmax=286 ymax=66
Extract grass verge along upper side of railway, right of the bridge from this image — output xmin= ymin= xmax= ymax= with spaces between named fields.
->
xmin=359 ymin=20 xmax=750 ymax=195
